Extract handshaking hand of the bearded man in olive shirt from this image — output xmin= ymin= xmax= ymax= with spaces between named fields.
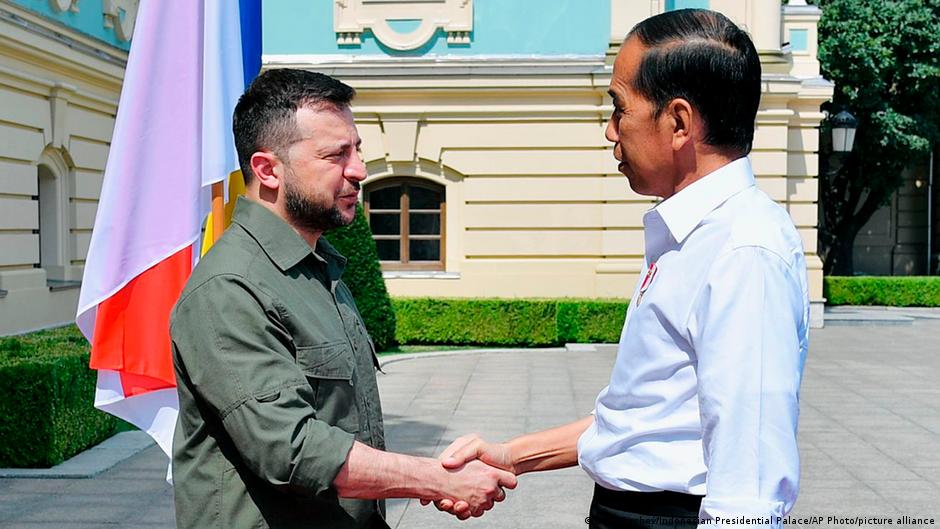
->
xmin=436 ymin=460 xmax=517 ymax=520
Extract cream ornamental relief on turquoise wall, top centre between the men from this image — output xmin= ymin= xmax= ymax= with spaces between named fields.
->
xmin=333 ymin=0 xmax=473 ymax=51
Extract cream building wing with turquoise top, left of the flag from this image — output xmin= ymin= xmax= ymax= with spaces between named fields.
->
xmin=0 ymin=0 xmax=129 ymax=335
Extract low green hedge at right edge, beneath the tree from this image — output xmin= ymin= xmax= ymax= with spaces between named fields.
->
xmin=823 ymin=276 xmax=940 ymax=307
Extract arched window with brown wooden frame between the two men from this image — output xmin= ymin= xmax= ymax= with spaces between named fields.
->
xmin=363 ymin=178 xmax=445 ymax=270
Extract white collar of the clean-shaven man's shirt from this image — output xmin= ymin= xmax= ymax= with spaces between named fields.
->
xmin=643 ymin=157 xmax=754 ymax=243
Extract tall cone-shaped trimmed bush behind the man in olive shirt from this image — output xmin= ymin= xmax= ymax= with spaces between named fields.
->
xmin=326 ymin=202 xmax=395 ymax=351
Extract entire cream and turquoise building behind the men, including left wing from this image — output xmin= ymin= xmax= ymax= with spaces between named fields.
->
xmin=0 ymin=0 xmax=832 ymax=335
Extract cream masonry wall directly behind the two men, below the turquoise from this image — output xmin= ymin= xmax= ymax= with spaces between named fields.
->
xmin=263 ymin=0 xmax=832 ymax=324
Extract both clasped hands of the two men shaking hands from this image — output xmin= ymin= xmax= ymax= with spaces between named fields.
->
xmin=421 ymin=435 xmax=516 ymax=520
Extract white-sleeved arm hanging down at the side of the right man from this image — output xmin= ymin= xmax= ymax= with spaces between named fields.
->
xmin=689 ymin=246 xmax=807 ymax=527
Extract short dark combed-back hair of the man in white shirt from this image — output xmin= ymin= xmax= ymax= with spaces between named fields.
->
xmin=627 ymin=9 xmax=761 ymax=154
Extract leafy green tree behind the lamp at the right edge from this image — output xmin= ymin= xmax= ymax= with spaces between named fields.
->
xmin=815 ymin=0 xmax=940 ymax=275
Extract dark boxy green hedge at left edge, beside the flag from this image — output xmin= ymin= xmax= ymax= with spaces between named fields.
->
xmin=0 ymin=326 xmax=127 ymax=467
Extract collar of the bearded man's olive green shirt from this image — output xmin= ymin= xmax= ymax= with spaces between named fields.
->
xmin=232 ymin=197 xmax=346 ymax=278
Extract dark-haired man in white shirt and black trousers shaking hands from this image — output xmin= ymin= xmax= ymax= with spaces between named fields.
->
xmin=437 ymin=10 xmax=809 ymax=529
